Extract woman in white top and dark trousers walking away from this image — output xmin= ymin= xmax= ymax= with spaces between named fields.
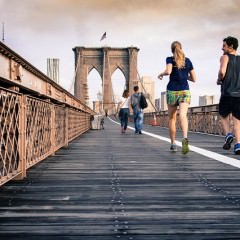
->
xmin=119 ymin=90 xmax=130 ymax=133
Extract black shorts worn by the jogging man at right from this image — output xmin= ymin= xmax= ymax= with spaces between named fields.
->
xmin=219 ymin=96 xmax=240 ymax=120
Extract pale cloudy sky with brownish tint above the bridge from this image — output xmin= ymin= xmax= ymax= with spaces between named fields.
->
xmin=0 ymin=0 xmax=240 ymax=106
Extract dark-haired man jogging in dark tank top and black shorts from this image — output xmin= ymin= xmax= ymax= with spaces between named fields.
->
xmin=217 ymin=37 xmax=240 ymax=155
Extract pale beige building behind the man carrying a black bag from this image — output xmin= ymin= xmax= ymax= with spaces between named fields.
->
xmin=138 ymin=76 xmax=155 ymax=112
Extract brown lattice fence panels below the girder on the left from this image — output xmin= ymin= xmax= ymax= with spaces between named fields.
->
xmin=0 ymin=88 xmax=90 ymax=185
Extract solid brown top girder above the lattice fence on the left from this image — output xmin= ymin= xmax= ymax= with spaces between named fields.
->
xmin=0 ymin=41 xmax=93 ymax=114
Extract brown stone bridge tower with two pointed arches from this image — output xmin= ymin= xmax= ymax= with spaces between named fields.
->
xmin=73 ymin=47 xmax=139 ymax=112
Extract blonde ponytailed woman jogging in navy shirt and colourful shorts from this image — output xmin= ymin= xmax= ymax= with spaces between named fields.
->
xmin=158 ymin=41 xmax=196 ymax=154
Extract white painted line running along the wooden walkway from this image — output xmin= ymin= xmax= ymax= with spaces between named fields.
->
xmin=109 ymin=118 xmax=240 ymax=168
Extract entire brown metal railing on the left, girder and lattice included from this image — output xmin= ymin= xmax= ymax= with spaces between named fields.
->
xmin=0 ymin=42 xmax=94 ymax=186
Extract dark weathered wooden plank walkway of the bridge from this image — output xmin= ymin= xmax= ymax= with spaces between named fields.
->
xmin=0 ymin=120 xmax=240 ymax=240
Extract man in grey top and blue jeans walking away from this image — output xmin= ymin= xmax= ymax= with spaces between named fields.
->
xmin=130 ymin=86 xmax=143 ymax=134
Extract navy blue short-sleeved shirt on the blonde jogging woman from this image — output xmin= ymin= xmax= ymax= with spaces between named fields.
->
xmin=166 ymin=57 xmax=193 ymax=91
